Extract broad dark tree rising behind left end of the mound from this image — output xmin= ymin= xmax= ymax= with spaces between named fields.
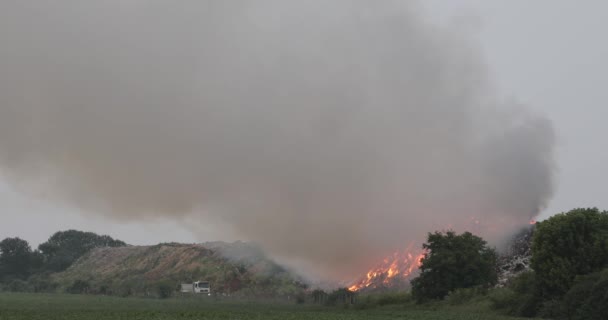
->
xmin=38 ymin=230 xmax=127 ymax=272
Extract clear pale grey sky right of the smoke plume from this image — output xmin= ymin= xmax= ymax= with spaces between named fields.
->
xmin=425 ymin=0 xmax=608 ymax=218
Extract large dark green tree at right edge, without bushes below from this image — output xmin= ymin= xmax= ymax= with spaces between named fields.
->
xmin=531 ymin=208 xmax=608 ymax=299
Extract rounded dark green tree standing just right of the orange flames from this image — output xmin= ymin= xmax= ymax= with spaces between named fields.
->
xmin=412 ymin=231 xmax=498 ymax=302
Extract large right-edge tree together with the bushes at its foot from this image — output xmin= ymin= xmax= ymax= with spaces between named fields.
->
xmin=491 ymin=208 xmax=608 ymax=319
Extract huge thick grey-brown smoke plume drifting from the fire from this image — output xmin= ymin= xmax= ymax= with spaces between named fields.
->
xmin=0 ymin=0 xmax=554 ymax=275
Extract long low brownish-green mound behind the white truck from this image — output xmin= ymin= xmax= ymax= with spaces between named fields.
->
xmin=53 ymin=242 xmax=305 ymax=297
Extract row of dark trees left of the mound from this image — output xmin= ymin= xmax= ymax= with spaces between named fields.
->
xmin=0 ymin=230 xmax=127 ymax=291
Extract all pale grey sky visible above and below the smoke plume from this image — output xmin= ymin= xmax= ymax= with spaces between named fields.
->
xmin=0 ymin=0 xmax=608 ymax=250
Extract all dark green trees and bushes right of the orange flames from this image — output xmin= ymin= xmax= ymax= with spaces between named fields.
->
xmin=394 ymin=208 xmax=608 ymax=319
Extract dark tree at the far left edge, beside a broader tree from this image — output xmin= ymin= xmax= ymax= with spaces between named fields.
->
xmin=0 ymin=238 xmax=33 ymax=278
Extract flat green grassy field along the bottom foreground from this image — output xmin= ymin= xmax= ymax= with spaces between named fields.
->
xmin=0 ymin=293 xmax=540 ymax=320
